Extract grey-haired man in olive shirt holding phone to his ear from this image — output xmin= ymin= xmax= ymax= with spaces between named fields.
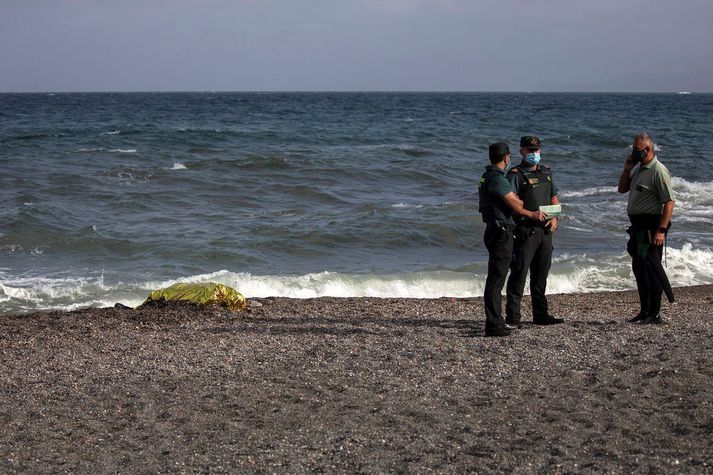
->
xmin=619 ymin=133 xmax=674 ymax=323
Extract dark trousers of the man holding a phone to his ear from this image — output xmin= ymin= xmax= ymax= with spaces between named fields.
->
xmin=626 ymin=215 xmax=663 ymax=316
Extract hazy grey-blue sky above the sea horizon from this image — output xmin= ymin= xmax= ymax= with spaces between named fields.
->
xmin=0 ymin=0 xmax=713 ymax=92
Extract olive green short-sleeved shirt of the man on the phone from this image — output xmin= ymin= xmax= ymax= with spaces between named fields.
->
xmin=626 ymin=157 xmax=673 ymax=215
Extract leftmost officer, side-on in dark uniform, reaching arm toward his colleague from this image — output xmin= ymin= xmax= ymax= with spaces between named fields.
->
xmin=478 ymin=142 xmax=545 ymax=336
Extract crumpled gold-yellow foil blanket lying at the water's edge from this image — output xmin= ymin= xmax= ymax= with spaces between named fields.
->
xmin=143 ymin=282 xmax=246 ymax=311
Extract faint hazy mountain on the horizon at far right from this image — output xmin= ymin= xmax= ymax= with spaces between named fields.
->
xmin=533 ymin=70 xmax=713 ymax=92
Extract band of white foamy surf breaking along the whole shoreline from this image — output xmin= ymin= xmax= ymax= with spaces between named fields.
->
xmin=0 ymin=244 xmax=713 ymax=314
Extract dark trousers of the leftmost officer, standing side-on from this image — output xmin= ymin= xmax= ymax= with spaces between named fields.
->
xmin=483 ymin=223 xmax=513 ymax=329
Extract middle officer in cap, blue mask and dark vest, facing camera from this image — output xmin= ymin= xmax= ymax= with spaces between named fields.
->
xmin=506 ymin=136 xmax=564 ymax=326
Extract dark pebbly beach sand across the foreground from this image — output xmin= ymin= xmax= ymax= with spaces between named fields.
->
xmin=0 ymin=286 xmax=713 ymax=473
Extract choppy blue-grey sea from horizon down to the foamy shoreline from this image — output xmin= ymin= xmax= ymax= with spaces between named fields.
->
xmin=0 ymin=93 xmax=713 ymax=313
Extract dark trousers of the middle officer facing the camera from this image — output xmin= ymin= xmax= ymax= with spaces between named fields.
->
xmin=506 ymin=225 xmax=552 ymax=322
